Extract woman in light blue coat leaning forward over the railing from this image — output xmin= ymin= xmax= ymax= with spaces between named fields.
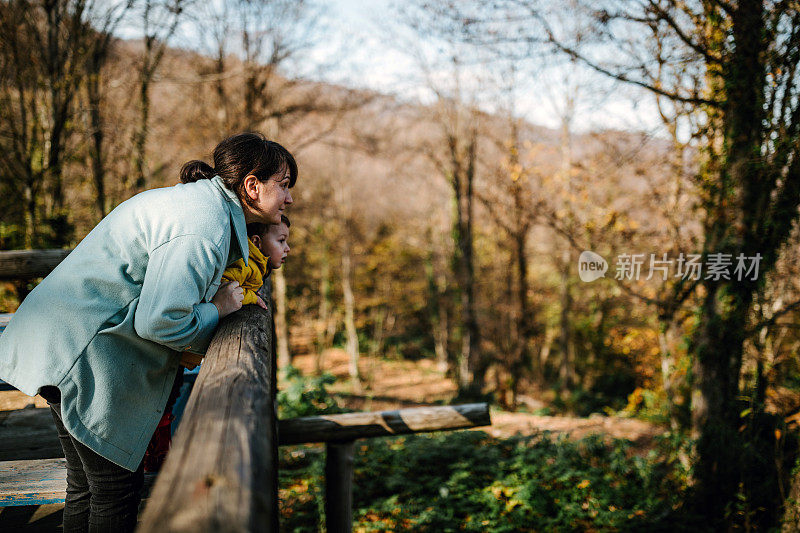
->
xmin=0 ymin=133 xmax=297 ymax=533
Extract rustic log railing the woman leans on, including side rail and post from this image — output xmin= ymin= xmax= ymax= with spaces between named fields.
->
xmin=0 ymin=250 xmax=491 ymax=533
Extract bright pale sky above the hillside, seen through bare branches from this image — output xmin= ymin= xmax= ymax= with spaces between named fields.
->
xmin=119 ymin=0 xmax=660 ymax=135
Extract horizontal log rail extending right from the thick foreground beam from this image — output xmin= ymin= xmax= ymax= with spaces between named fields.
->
xmin=278 ymin=403 xmax=492 ymax=445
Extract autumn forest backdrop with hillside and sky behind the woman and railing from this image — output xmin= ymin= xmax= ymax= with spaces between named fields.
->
xmin=0 ymin=0 xmax=800 ymax=532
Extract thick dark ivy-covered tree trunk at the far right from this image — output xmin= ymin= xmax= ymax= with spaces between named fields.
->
xmin=692 ymin=2 xmax=780 ymax=526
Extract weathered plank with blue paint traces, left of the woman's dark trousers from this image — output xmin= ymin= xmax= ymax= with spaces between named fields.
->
xmin=0 ymin=459 xmax=67 ymax=507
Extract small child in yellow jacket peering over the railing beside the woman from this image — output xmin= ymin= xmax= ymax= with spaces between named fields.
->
xmin=144 ymin=215 xmax=291 ymax=472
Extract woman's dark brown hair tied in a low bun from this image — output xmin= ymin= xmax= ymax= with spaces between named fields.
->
xmin=181 ymin=132 xmax=297 ymax=197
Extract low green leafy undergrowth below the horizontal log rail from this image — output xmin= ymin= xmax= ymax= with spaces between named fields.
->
xmin=281 ymin=431 xmax=702 ymax=533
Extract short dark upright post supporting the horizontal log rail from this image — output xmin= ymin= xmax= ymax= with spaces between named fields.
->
xmin=325 ymin=441 xmax=356 ymax=533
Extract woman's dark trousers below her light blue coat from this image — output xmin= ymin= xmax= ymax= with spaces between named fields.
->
xmin=42 ymin=389 xmax=144 ymax=533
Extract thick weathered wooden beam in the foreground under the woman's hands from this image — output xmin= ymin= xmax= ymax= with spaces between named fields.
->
xmin=139 ymin=305 xmax=278 ymax=533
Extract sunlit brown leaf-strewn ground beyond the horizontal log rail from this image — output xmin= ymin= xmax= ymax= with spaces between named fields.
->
xmin=292 ymin=349 xmax=665 ymax=454
